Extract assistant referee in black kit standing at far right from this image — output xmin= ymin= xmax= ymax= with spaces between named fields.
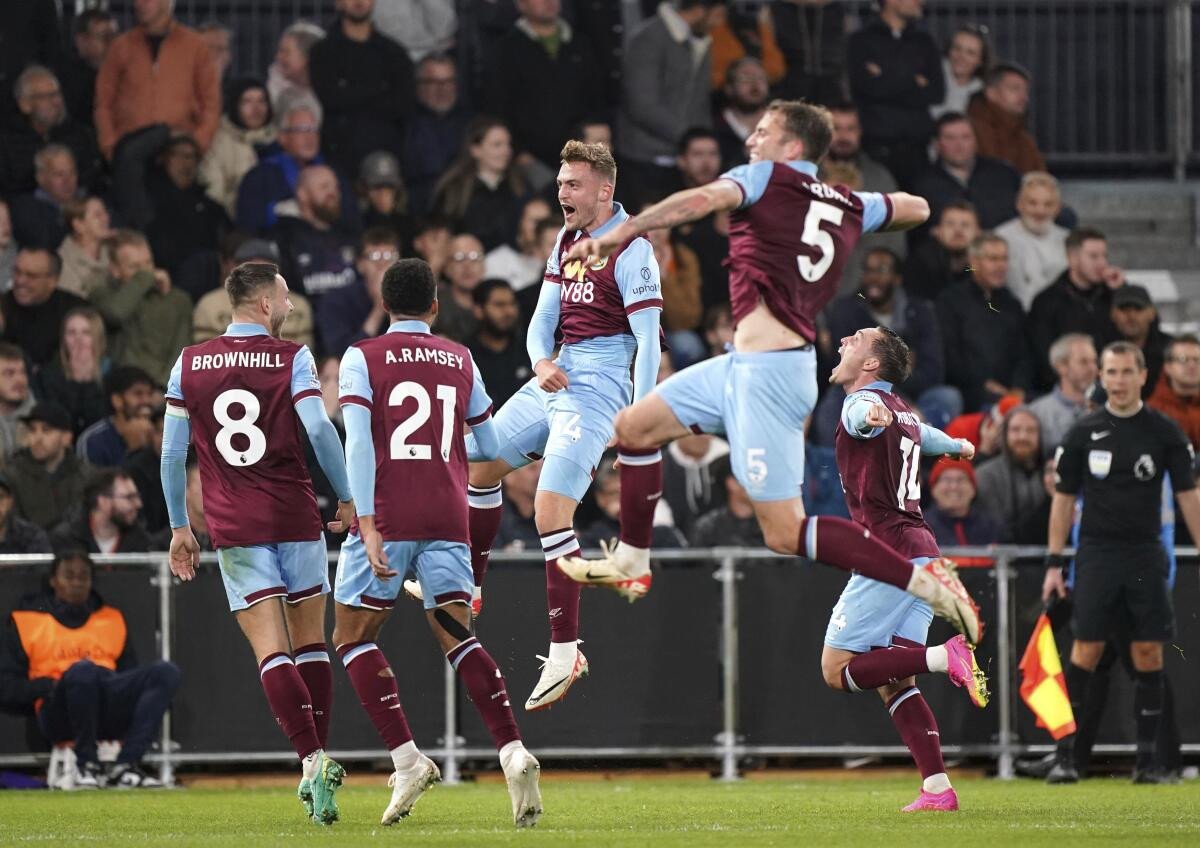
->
xmin=1042 ymin=342 xmax=1200 ymax=783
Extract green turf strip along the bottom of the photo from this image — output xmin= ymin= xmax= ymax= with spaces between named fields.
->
xmin=0 ymin=771 xmax=1200 ymax=848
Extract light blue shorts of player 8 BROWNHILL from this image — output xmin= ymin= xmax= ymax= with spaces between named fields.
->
xmin=217 ymin=534 xmax=329 ymax=612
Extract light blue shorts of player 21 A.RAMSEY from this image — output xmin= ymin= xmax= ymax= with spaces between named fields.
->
xmin=334 ymin=533 xmax=475 ymax=609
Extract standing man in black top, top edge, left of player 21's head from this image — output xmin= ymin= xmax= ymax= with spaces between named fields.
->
xmin=308 ymin=0 xmax=414 ymax=174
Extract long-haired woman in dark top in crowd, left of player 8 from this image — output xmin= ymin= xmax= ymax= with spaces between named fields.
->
xmin=34 ymin=306 xmax=108 ymax=434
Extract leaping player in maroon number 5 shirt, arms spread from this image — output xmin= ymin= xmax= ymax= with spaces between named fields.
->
xmin=559 ymin=101 xmax=979 ymax=643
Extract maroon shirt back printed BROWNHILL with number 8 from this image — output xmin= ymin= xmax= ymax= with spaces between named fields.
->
xmin=168 ymin=332 xmax=322 ymax=547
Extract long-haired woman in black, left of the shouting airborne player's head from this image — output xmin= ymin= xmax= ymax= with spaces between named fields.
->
xmin=433 ymin=118 xmax=527 ymax=251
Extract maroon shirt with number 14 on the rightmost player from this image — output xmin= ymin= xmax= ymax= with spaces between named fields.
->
xmin=834 ymin=389 xmax=938 ymax=559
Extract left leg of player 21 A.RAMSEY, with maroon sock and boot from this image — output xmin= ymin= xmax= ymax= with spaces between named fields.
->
xmin=334 ymin=603 xmax=442 ymax=825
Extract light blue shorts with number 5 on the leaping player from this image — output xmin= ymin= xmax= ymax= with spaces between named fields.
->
xmin=654 ymin=345 xmax=817 ymax=500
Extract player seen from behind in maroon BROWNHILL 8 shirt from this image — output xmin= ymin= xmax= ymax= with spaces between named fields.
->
xmin=161 ymin=263 xmax=354 ymax=824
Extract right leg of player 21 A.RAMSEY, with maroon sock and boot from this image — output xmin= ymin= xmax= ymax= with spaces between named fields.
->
xmin=425 ymin=602 xmax=541 ymax=828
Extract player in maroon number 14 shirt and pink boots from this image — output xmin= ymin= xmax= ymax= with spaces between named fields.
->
xmin=821 ymin=327 xmax=988 ymax=812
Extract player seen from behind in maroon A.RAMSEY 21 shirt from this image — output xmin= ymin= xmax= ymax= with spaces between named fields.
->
xmin=334 ymin=259 xmax=541 ymax=828
